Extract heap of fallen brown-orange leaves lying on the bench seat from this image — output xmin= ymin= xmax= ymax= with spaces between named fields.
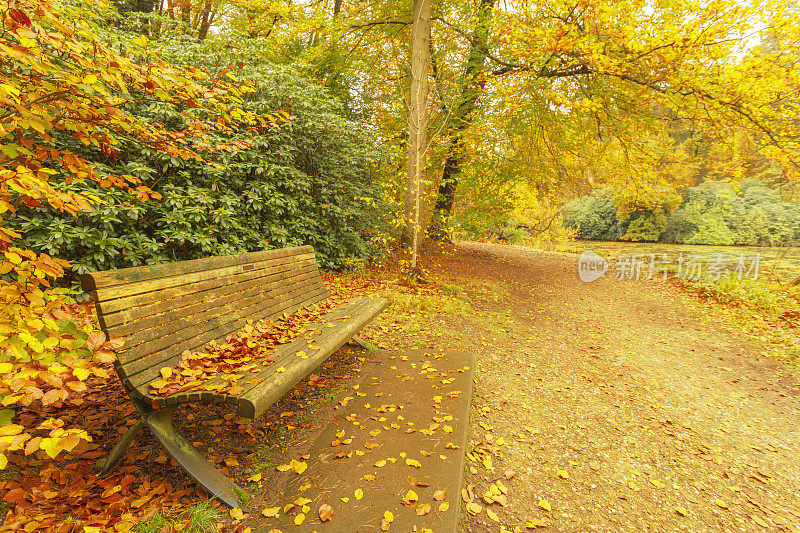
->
xmin=150 ymin=299 xmax=335 ymax=397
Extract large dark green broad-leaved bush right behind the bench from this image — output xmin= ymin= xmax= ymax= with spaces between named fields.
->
xmin=7 ymin=65 xmax=381 ymax=273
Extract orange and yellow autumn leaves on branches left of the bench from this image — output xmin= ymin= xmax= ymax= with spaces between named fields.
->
xmin=0 ymin=0 xmax=271 ymax=468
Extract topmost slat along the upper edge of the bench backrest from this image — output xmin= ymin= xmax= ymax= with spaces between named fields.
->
xmin=81 ymin=246 xmax=314 ymax=291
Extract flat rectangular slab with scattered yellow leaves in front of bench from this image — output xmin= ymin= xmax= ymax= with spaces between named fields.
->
xmin=253 ymin=350 xmax=474 ymax=533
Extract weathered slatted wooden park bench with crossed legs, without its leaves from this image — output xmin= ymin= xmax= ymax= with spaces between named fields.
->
xmin=81 ymin=246 xmax=388 ymax=507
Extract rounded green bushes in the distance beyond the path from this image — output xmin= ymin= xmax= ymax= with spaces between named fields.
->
xmin=564 ymin=181 xmax=800 ymax=246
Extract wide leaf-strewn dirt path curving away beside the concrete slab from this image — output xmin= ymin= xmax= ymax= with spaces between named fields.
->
xmin=433 ymin=243 xmax=800 ymax=532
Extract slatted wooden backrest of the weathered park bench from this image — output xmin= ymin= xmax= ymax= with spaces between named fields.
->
xmin=81 ymin=246 xmax=329 ymax=390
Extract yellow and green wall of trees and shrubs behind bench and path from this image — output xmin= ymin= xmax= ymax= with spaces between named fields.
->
xmin=0 ymin=0 xmax=800 ymax=468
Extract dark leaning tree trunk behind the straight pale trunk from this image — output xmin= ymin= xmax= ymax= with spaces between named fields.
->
xmin=428 ymin=0 xmax=495 ymax=240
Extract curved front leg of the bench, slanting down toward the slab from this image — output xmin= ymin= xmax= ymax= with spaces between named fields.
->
xmin=144 ymin=405 xmax=247 ymax=507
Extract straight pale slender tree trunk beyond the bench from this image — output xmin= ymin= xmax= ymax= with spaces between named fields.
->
xmin=403 ymin=0 xmax=431 ymax=274
